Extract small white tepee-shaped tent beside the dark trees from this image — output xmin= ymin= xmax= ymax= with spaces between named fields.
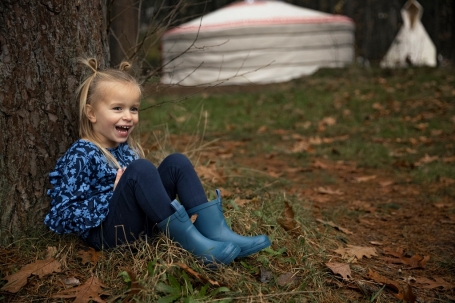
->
xmin=380 ymin=0 xmax=436 ymax=68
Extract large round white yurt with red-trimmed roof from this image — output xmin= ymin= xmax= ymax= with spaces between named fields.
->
xmin=161 ymin=1 xmax=355 ymax=86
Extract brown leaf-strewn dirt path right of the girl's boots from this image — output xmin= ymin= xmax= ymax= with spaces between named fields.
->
xmin=180 ymin=137 xmax=455 ymax=302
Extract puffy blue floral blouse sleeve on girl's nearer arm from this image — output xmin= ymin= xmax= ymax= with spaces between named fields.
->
xmin=44 ymin=147 xmax=115 ymax=235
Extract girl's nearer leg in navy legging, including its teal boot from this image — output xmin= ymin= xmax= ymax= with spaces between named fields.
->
xmin=87 ymin=159 xmax=240 ymax=264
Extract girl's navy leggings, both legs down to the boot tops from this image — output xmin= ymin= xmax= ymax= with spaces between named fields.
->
xmin=86 ymin=154 xmax=207 ymax=249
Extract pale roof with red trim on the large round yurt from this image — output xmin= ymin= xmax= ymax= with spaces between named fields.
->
xmin=165 ymin=0 xmax=353 ymax=35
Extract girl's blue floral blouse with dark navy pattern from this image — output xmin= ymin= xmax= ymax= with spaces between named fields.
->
xmin=44 ymin=140 xmax=139 ymax=238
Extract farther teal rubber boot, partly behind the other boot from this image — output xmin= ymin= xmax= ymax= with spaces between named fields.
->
xmin=187 ymin=189 xmax=270 ymax=258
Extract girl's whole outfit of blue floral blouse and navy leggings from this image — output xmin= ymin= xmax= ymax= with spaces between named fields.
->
xmin=44 ymin=140 xmax=207 ymax=249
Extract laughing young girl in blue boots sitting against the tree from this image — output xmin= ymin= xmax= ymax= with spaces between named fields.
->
xmin=44 ymin=59 xmax=270 ymax=264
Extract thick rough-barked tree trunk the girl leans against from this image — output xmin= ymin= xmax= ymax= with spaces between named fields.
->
xmin=0 ymin=0 xmax=109 ymax=243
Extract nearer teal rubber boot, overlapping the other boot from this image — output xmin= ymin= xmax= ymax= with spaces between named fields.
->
xmin=158 ymin=200 xmax=240 ymax=265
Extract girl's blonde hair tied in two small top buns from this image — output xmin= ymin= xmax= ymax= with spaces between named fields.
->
xmin=76 ymin=58 xmax=145 ymax=168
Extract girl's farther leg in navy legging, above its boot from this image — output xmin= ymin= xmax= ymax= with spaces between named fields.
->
xmin=158 ymin=154 xmax=207 ymax=209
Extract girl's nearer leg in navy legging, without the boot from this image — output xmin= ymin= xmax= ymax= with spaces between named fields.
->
xmin=88 ymin=159 xmax=175 ymax=249
